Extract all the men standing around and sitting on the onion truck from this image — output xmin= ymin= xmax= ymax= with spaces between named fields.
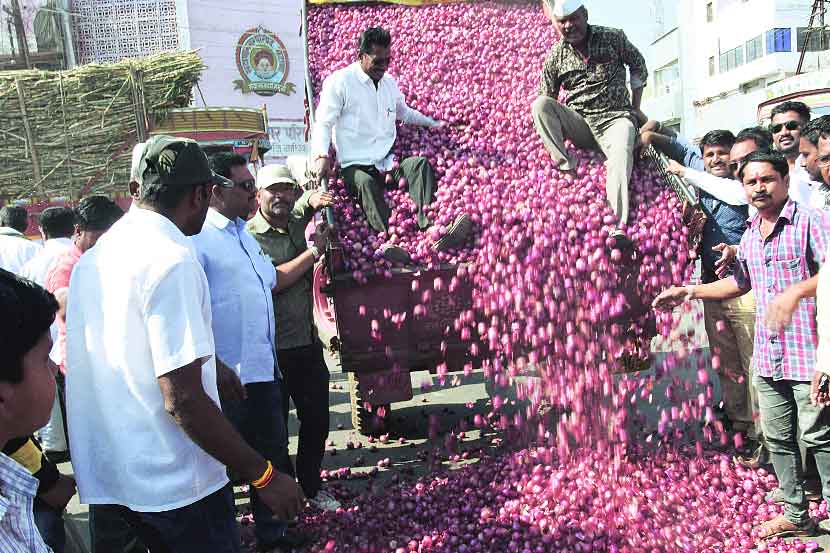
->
xmin=0 ymin=0 xmax=830 ymax=553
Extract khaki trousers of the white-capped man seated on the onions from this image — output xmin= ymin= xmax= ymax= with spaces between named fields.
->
xmin=532 ymin=96 xmax=637 ymax=226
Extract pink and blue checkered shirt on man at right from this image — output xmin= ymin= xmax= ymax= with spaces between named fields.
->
xmin=735 ymin=200 xmax=830 ymax=382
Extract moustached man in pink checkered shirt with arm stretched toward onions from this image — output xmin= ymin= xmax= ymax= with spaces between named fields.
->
xmin=653 ymin=151 xmax=830 ymax=539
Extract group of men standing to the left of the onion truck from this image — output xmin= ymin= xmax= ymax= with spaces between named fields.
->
xmin=0 ymin=136 xmax=340 ymax=553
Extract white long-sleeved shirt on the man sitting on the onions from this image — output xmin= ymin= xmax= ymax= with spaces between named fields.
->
xmin=311 ymin=62 xmax=439 ymax=171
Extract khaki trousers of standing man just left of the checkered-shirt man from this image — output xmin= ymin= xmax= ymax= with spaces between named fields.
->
xmin=703 ymin=291 xmax=762 ymax=439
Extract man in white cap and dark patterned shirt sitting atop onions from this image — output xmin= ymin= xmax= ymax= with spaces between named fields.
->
xmin=532 ymin=0 xmax=648 ymax=245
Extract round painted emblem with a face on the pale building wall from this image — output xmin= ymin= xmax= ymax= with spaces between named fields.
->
xmin=233 ymin=27 xmax=297 ymax=96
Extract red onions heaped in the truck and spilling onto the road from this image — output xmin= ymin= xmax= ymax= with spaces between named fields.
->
xmin=264 ymin=2 xmax=825 ymax=553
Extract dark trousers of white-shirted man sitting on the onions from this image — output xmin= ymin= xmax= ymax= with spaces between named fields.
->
xmin=341 ymin=157 xmax=436 ymax=232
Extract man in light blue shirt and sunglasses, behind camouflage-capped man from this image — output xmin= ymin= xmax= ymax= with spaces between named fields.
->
xmin=191 ymin=153 xmax=304 ymax=551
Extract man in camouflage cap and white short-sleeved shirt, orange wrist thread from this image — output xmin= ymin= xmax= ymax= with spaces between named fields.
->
xmin=66 ymin=137 xmax=302 ymax=553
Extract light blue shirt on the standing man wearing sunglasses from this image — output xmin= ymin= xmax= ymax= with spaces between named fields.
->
xmin=191 ymin=208 xmax=277 ymax=384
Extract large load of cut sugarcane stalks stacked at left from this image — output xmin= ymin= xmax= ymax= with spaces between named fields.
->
xmin=0 ymin=52 xmax=204 ymax=199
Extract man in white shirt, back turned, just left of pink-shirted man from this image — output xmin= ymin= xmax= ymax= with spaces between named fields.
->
xmin=21 ymin=206 xmax=75 ymax=457
